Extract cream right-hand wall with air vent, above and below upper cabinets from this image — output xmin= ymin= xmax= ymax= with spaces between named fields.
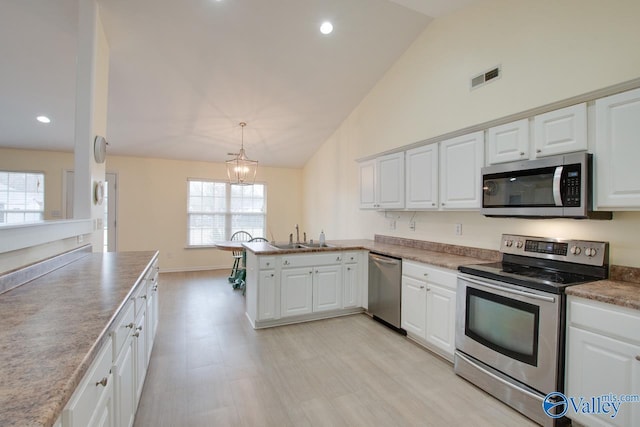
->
xmin=303 ymin=0 xmax=640 ymax=267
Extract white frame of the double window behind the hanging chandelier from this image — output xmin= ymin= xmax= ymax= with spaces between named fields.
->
xmin=185 ymin=178 xmax=268 ymax=249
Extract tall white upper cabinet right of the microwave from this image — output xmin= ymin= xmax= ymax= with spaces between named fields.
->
xmin=594 ymin=89 xmax=640 ymax=210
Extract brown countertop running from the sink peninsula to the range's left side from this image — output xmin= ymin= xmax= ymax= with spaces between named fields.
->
xmin=243 ymin=236 xmax=500 ymax=270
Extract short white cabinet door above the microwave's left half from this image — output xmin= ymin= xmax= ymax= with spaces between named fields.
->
xmin=487 ymin=119 xmax=529 ymax=165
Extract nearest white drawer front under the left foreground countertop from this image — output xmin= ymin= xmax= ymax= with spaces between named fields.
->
xmin=62 ymin=340 xmax=113 ymax=427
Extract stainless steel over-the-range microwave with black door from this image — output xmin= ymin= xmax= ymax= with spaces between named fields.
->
xmin=481 ymin=152 xmax=611 ymax=219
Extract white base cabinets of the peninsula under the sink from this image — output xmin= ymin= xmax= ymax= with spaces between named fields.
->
xmin=246 ymin=251 xmax=366 ymax=328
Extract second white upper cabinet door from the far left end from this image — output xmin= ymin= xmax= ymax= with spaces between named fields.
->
xmin=376 ymin=152 xmax=404 ymax=209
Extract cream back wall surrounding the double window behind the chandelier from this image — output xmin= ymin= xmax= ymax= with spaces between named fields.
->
xmin=107 ymin=155 xmax=304 ymax=271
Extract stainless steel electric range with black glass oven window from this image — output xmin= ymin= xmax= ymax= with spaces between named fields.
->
xmin=454 ymin=234 xmax=609 ymax=426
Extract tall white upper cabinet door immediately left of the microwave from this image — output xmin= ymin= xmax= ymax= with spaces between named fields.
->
xmin=440 ymin=131 xmax=484 ymax=209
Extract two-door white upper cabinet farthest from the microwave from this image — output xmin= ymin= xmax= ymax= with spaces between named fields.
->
xmin=359 ymin=152 xmax=404 ymax=209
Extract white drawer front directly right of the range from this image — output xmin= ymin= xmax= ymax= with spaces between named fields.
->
xmin=568 ymin=296 xmax=640 ymax=343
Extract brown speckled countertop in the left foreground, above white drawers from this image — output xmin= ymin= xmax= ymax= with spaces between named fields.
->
xmin=0 ymin=251 xmax=158 ymax=427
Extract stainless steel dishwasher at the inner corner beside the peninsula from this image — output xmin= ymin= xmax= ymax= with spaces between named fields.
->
xmin=368 ymin=253 xmax=402 ymax=332
